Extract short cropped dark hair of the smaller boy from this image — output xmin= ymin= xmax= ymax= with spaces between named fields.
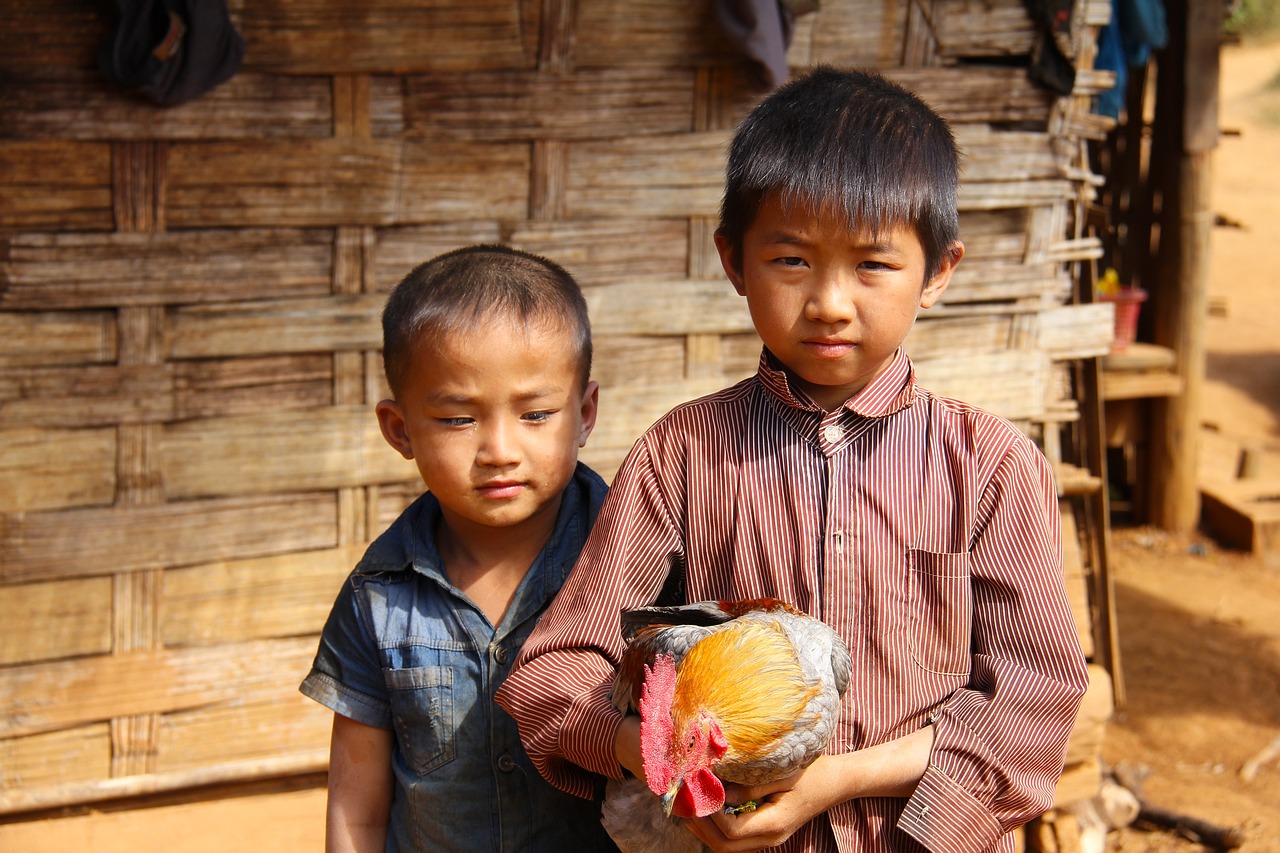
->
xmin=383 ymin=243 xmax=591 ymax=394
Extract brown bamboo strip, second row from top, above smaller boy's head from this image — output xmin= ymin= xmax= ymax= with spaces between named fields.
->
xmin=403 ymin=68 xmax=694 ymax=141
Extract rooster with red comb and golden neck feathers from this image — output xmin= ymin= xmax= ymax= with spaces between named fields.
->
xmin=602 ymin=598 xmax=851 ymax=853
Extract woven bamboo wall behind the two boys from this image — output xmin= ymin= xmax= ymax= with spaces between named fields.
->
xmin=0 ymin=0 xmax=1110 ymax=812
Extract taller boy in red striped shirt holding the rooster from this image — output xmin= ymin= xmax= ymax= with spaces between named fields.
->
xmin=498 ymin=68 xmax=1087 ymax=852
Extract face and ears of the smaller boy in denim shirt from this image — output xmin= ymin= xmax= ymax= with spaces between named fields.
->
xmin=378 ymin=316 xmax=599 ymax=538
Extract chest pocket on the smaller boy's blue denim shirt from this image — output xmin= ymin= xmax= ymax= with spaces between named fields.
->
xmin=383 ymin=666 xmax=454 ymax=775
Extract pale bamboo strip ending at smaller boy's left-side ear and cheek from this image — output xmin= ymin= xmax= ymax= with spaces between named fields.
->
xmin=159 ymin=405 xmax=417 ymax=501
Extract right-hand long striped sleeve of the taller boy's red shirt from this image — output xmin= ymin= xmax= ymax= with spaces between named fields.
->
xmin=899 ymin=438 xmax=1088 ymax=853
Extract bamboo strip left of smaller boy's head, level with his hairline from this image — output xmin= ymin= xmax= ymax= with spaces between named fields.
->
xmin=166 ymin=293 xmax=387 ymax=359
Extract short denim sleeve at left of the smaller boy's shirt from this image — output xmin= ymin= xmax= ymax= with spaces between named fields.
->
xmin=298 ymin=578 xmax=392 ymax=729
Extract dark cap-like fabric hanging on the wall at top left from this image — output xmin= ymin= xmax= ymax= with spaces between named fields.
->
xmin=97 ymin=0 xmax=244 ymax=106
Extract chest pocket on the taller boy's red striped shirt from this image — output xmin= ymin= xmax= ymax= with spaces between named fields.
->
xmin=908 ymin=549 xmax=973 ymax=675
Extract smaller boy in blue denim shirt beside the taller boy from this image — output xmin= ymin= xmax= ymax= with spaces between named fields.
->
xmin=301 ymin=246 xmax=614 ymax=853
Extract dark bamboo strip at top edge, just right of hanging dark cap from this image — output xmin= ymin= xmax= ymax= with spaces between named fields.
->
xmin=239 ymin=0 xmax=539 ymax=74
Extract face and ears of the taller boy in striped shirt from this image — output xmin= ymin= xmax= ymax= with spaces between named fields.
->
xmin=716 ymin=193 xmax=964 ymax=411
